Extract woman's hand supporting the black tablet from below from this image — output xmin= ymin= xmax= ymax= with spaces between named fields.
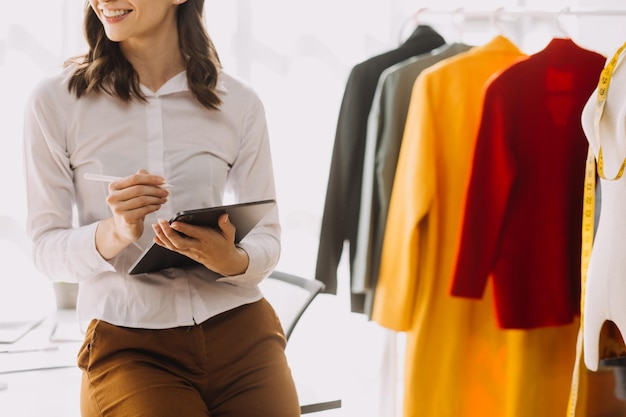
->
xmin=152 ymin=214 xmax=250 ymax=275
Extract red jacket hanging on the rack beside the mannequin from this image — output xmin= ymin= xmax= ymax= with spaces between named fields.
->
xmin=451 ymin=39 xmax=606 ymax=329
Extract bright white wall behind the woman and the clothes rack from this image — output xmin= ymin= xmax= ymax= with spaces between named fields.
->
xmin=0 ymin=0 xmax=626 ymax=276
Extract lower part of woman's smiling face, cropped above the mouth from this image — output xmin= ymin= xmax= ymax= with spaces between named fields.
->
xmin=89 ymin=0 xmax=187 ymax=42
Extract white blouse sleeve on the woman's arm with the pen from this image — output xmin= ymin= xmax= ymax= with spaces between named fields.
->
xmin=23 ymin=79 xmax=114 ymax=282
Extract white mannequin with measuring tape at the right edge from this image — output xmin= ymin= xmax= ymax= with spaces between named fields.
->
xmin=582 ymin=44 xmax=626 ymax=371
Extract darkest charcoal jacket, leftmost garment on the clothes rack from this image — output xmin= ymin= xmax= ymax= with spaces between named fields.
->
xmin=315 ymin=25 xmax=445 ymax=312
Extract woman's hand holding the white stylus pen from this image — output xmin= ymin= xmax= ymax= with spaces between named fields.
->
xmin=96 ymin=169 xmax=169 ymax=259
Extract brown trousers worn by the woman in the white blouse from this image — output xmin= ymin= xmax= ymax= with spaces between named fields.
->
xmin=78 ymin=299 xmax=300 ymax=417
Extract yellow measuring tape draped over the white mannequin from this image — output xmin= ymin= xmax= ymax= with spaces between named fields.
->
xmin=567 ymin=43 xmax=626 ymax=417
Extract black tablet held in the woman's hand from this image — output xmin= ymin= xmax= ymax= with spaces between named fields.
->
xmin=128 ymin=200 xmax=276 ymax=275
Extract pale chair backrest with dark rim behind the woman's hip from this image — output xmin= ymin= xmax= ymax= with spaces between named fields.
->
xmin=260 ymin=271 xmax=324 ymax=340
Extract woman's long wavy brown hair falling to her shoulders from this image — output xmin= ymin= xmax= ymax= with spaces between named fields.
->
xmin=65 ymin=0 xmax=221 ymax=109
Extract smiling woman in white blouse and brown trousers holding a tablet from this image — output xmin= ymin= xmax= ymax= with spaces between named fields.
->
xmin=24 ymin=0 xmax=300 ymax=417
